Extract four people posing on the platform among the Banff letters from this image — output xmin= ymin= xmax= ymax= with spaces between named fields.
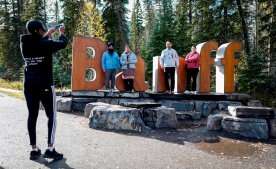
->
xmin=102 ymin=41 xmax=199 ymax=94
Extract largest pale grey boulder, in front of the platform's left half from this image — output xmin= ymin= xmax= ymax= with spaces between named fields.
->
xmin=89 ymin=105 xmax=148 ymax=132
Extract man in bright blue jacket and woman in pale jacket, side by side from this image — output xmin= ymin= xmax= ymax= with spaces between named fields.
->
xmin=102 ymin=42 xmax=137 ymax=92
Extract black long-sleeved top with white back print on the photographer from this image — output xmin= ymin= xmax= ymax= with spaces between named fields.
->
xmin=20 ymin=35 xmax=68 ymax=87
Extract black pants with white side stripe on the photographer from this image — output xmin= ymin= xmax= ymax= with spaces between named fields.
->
xmin=24 ymin=85 xmax=56 ymax=145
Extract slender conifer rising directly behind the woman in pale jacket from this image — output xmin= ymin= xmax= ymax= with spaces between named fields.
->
xmin=130 ymin=0 xmax=144 ymax=53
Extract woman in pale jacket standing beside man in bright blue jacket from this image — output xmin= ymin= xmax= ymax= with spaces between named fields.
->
xmin=120 ymin=45 xmax=137 ymax=92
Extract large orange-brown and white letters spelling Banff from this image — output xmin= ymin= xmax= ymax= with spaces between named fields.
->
xmin=72 ymin=36 xmax=241 ymax=93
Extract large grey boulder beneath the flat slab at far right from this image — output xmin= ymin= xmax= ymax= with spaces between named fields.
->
xmin=222 ymin=116 xmax=268 ymax=140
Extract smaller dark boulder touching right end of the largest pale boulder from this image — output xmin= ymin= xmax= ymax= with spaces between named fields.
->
xmin=143 ymin=106 xmax=177 ymax=129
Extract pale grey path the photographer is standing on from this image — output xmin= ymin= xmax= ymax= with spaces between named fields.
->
xmin=0 ymin=93 xmax=276 ymax=169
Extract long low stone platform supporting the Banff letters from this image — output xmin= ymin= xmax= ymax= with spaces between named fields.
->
xmin=56 ymin=90 xmax=251 ymax=113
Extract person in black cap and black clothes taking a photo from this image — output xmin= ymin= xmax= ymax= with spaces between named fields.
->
xmin=20 ymin=20 xmax=68 ymax=160
